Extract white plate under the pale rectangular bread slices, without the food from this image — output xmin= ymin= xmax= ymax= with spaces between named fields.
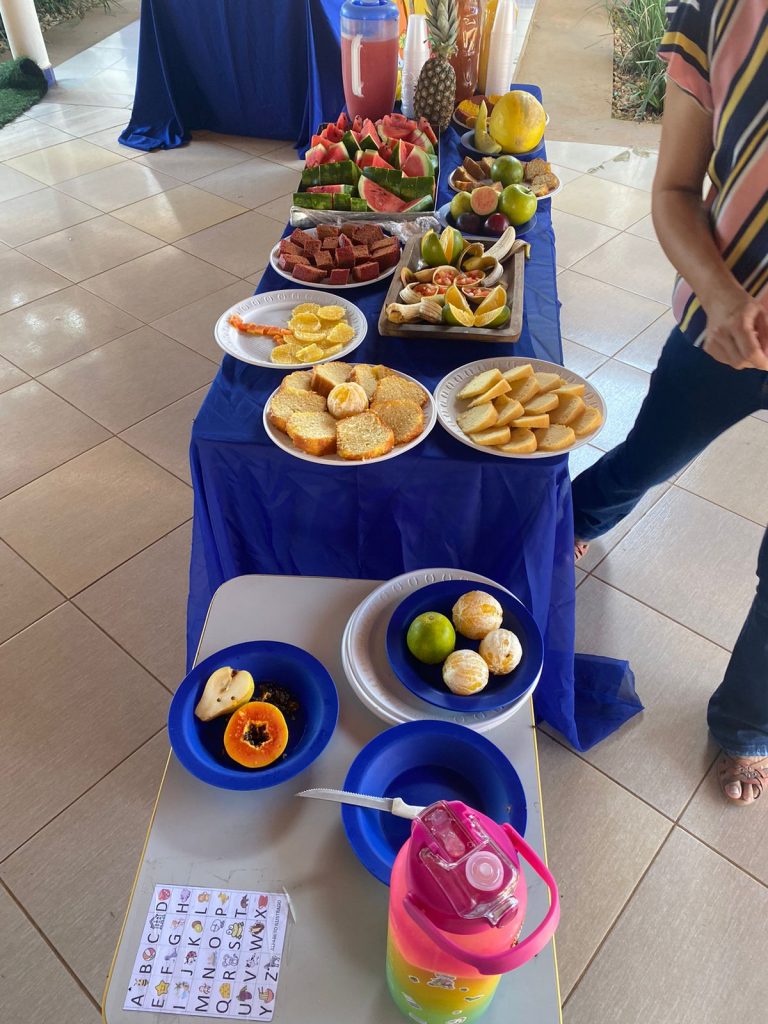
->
xmin=434 ymin=355 xmax=607 ymax=460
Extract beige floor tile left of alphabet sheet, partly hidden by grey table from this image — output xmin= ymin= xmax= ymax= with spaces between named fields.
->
xmin=0 ymin=730 xmax=169 ymax=1003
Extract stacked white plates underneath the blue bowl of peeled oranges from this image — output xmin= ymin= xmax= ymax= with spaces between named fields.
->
xmin=341 ymin=568 xmax=536 ymax=732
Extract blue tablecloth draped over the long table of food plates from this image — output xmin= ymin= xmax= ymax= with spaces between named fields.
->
xmin=187 ymin=103 xmax=642 ymax=750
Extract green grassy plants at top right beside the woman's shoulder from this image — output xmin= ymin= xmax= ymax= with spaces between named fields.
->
xmin=608 ymin=0 xmax=667 ymax=115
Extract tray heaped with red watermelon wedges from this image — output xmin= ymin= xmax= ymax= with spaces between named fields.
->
xmin=293 ymin=113 xmax=437 ymax=216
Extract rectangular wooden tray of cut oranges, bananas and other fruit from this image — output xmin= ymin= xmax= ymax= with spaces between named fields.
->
xmin=379 ymin=227 xmax=528 ymax=342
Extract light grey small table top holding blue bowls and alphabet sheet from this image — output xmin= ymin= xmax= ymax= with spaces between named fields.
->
xmin=103 ymin=575 xmax=561 ymax=1024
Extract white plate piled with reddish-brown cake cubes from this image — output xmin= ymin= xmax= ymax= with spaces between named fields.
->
xmin=269 ymin=222 xmax=400 ymax=291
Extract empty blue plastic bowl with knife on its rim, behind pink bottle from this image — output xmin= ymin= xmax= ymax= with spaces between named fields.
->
xmin=341 ymin=720 xmax=527 ymax=886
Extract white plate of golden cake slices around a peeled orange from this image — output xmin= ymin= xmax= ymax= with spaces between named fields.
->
xmin=264 ymin=361 xmax=436 ymax=466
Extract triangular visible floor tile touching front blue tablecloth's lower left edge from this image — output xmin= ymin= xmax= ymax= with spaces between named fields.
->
xmin=75 ymin=523 xmax=191 ymax=692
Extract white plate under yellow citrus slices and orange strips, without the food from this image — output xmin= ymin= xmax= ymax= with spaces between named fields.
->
xmin=213 ymin=288 xmax=368 ymax=372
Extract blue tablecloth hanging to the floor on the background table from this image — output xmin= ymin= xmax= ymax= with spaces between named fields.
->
xmin=120 ymin=0 xmax=344 ymax=150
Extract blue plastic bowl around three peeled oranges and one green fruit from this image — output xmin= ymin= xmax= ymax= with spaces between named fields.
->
xmin=386 ymin=580 xmax=544 ymax=713
